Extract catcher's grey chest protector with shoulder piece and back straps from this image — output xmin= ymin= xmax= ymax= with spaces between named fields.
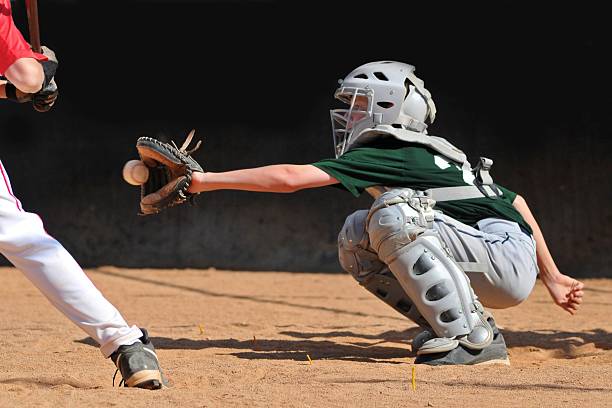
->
xmin=351 ymin=125 xmax=502 ymax=202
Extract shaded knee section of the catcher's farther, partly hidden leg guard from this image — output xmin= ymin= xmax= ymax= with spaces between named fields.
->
xmin=338 ymin=210 xmax=386 ymax=283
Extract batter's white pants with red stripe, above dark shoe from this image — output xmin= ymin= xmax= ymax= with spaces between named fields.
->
xmin=0 ymin=162 xmax=142 ymax=357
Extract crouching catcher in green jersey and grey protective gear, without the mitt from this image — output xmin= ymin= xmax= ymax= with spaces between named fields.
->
xmin=177 ymin=61 xmax=584 ymax=365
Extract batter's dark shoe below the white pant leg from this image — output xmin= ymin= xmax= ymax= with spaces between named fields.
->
xmin=111 ymin=329 xmax=167 ymax=390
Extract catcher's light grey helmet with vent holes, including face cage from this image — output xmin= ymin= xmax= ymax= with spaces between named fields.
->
xmin=330 ymin=61 xmax=436 ymax=157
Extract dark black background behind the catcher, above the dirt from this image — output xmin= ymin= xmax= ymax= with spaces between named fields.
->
xmin=0 ymin=0 xmax=612 ymax=277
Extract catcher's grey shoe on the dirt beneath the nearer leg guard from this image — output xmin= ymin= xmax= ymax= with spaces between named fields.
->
xmin=413 ymin=316 xmax=510 ymax=366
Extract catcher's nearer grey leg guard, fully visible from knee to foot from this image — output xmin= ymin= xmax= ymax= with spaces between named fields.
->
xmin=368 ymin=190 xmax=493 ymax=353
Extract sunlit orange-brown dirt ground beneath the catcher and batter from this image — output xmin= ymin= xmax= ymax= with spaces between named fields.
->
xmin=0 ymin=267 xmax=612 ymax=408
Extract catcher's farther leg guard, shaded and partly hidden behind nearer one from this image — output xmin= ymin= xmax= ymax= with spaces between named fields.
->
xmin=338 ymin=210 xmax=428 ymax=326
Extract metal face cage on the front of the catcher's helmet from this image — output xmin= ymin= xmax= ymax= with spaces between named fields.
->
xmin=330 ymin=87 xmax=374 ymax=158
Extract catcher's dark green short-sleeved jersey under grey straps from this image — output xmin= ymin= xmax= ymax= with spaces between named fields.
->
xmin=312 ymin=137 xmax=531 ymax=233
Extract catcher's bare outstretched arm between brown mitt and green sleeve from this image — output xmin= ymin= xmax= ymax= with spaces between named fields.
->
xmin=187 ymin=164 xmax=338 ymax=193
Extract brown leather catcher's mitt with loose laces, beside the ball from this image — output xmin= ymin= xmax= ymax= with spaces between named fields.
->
xmin=136 ymin=130 xmax=204 ymax=215
